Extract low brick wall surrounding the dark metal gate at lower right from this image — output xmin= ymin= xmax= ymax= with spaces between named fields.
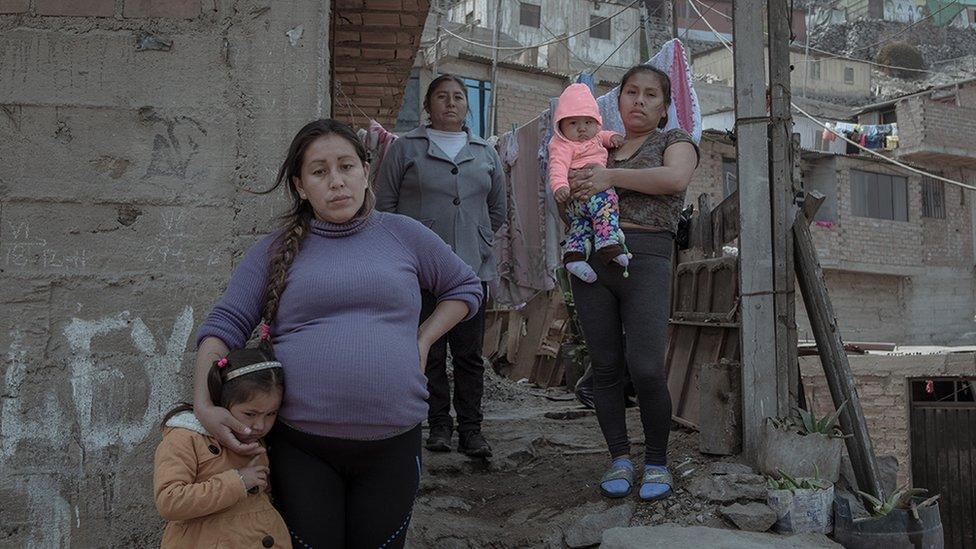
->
xmin=800 ymin=353 xmax=976 ymax=485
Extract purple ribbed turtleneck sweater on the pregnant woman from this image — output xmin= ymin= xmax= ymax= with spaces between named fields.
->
xmin=197 ymin=212 xmax=482 ymax=439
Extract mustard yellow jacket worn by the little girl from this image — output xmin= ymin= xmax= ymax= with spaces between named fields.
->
xmin=153 ymin=412 xmax=291 ymax=549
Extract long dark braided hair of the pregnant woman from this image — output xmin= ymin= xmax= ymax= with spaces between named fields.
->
xmin=258 ymin=118 xmax=376 ymax=326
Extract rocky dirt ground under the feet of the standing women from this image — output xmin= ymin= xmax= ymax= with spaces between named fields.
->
xmin=408 ymin=373 xmax=832 ymax=549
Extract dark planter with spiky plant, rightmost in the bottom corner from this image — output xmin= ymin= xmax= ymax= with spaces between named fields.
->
xmin=834 ymin=486 xmax=944 ymax=549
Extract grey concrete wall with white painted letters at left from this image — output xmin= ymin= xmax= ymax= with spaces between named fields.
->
xmin=0 ymin=0 xmax=331 ymax=547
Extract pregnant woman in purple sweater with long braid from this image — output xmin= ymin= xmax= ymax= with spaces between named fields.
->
xmin=194 ymin=120 xmax=482 ymax=547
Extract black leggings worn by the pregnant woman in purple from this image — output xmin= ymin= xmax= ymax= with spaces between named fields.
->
xmin=269 ymin=422 xmax=420 ymax=549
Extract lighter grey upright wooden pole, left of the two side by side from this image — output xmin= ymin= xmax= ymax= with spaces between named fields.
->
xmin=732 ymin=0 xmax=780 ymax=462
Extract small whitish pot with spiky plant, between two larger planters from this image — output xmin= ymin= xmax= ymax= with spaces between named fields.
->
xmin=766 ymin=471 xmax=834 ymax=534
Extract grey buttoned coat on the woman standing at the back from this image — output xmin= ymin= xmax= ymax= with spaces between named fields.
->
xmin=373 ymin=127 xmax=508 ymax=281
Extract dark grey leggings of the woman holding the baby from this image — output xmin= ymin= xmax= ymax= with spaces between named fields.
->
xmin=570 ymin=229 xmax=673 ymax=465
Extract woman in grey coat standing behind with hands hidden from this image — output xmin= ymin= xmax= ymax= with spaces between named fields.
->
xmin=375 ymin=74 xmax=507 ymax=457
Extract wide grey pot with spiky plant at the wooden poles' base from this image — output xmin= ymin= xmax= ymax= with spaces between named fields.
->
xmin=758 ymin=402 xmax=847 ymax=483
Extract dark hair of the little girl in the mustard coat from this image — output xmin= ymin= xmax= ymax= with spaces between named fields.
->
xmin=162 ymin=339 xmax=285 ymax=427
